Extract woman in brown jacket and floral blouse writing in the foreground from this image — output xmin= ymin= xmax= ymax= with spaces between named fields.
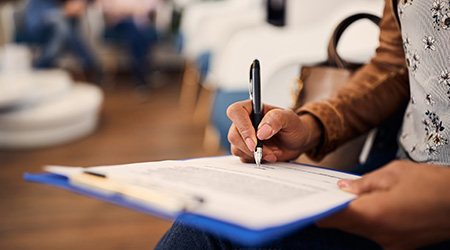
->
xmin=157 ymin=0 xmax=450 ymax=249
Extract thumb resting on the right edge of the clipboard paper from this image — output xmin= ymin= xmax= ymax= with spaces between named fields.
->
xmin=337 ymin=169 xmax=396 ymax=195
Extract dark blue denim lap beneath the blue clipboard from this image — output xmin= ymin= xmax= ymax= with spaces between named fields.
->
xmin=156 ymin=221 xmax=381 ymax=250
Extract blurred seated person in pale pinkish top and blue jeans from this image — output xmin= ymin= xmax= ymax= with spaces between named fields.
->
xmin=98 ymin=0 xmax=159 ymax=89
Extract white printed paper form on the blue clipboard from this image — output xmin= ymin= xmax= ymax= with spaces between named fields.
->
xmin=66 ymin=156 xmax=358 ymax=229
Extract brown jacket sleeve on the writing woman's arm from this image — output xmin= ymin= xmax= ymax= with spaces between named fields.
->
xmin=297 ymin=0 xmax=409 ymax=159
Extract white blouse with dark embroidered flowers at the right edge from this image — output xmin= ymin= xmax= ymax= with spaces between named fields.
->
xmin=398 ymin=0 xmax=450 ymax=165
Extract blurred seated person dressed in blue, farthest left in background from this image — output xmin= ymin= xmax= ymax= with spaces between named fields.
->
xmin=21 ymin=0 xmax=100 ymax=80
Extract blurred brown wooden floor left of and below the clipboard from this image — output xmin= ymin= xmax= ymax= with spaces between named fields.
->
xmin=0 ymin=71 xmax=220 ymax=249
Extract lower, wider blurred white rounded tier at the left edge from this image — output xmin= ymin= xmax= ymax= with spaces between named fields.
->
xmin=0 ymin=84 xmax=103 ymax=149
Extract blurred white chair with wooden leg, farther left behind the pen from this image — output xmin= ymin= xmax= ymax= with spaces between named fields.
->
xmin=180 ymin=0 xmax=264 ymax=110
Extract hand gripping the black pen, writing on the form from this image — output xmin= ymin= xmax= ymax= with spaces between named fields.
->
xmin=227 ymin=101 xmax=321 ymax=162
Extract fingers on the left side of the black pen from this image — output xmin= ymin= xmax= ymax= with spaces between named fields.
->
xmin=227 ymin=101 xmax=256 ymax=152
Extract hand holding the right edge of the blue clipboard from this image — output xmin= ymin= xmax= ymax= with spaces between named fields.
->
xmin=318 ymin=161 xmax=450 ymax=249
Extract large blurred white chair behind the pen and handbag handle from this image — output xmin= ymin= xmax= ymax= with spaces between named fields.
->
xmin=207 ymin=0 xmax=383 ymax=107
